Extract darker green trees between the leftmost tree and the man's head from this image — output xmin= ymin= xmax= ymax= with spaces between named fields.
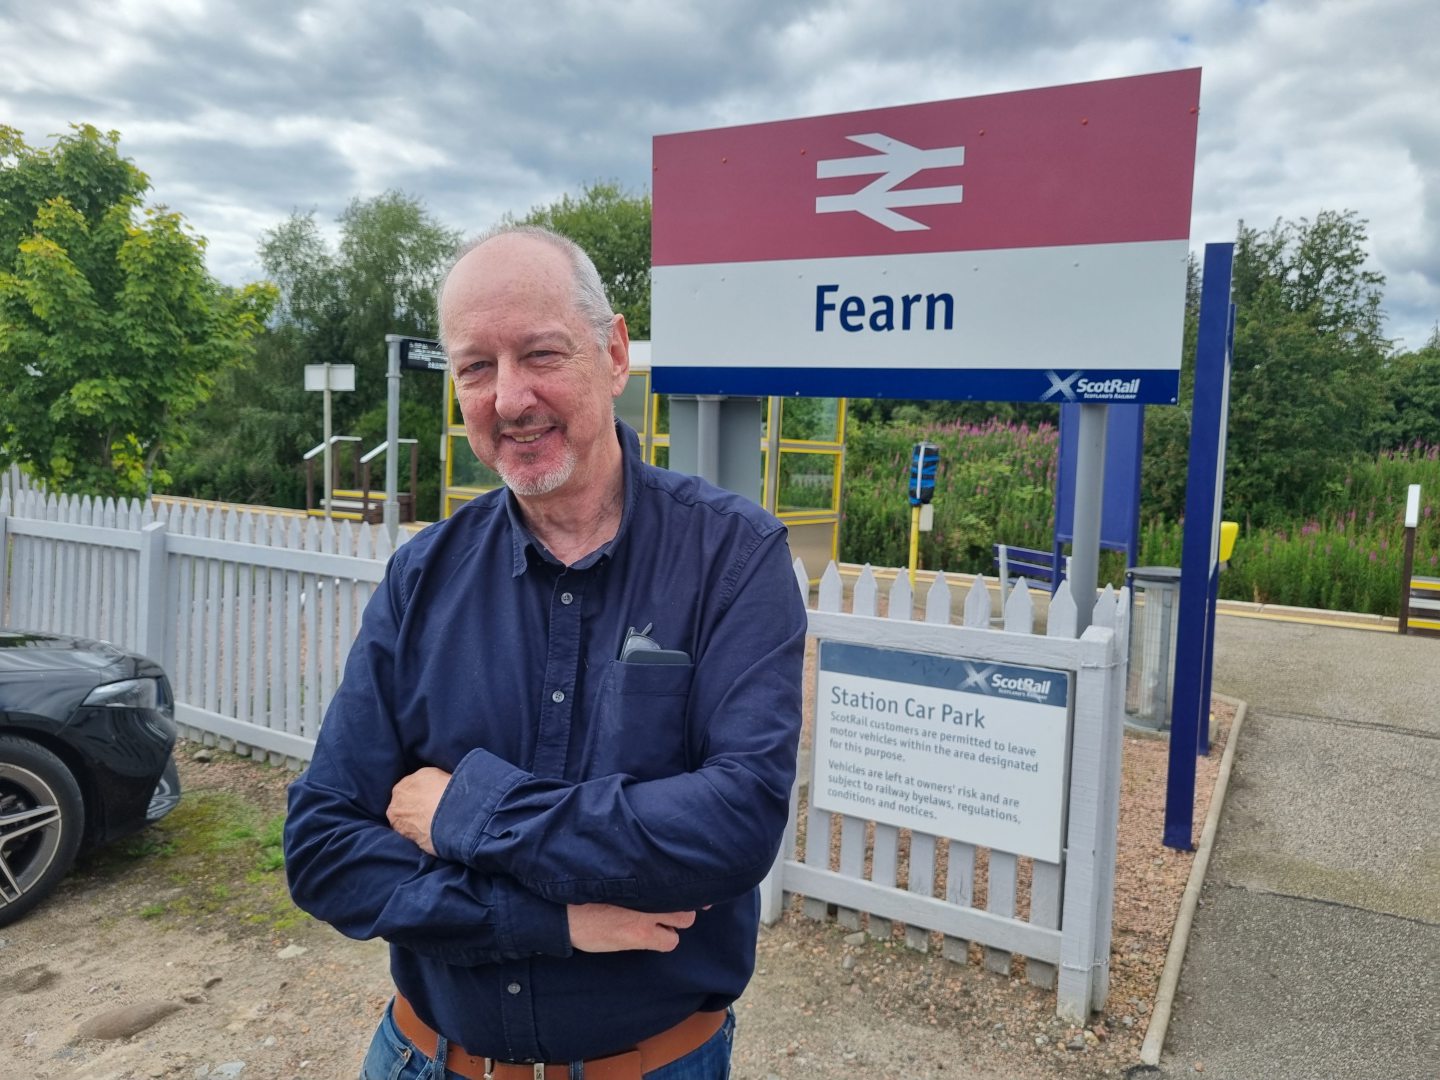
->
xmin=170 ymin=192 xmax=459 ymax=516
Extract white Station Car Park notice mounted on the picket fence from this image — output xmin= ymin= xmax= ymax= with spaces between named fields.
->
xmin=811 ymin=641 xmax=1070 ymax=863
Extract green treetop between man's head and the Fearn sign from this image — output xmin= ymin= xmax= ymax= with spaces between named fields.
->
xmin=505 ymin=181 xmax=649 ymax=341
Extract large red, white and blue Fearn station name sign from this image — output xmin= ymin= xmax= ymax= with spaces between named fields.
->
xmin=651 ymin=69 xmax=1200 ymax=403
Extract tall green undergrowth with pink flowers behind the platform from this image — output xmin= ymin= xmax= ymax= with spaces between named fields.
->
xmin=841 ymin=420 xmax=1440 ymax=615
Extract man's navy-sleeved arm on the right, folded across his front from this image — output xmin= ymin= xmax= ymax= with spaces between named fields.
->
xmin=431 ymin=533 xmax=806 ymax=910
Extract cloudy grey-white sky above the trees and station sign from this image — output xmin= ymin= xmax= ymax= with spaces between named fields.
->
xmin=0 ymin=0 xmax=1440 ymax=347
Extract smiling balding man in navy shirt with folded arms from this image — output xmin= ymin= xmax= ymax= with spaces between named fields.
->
xmin=285 ymin=228 xmax=805 ymax=1080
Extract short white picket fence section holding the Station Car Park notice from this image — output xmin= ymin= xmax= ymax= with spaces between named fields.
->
xmin=760 ymin=560 xmax=1129 ymax=1021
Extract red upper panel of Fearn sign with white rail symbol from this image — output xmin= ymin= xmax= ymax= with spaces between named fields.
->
xmin=654 ymin=69 xmax=1200 ymax=266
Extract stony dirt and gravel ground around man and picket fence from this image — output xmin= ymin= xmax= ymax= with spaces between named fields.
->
xmin=0 ymin=704 xmax=1231 ymax=1080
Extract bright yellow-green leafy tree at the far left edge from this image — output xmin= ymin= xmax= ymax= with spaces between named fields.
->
xmin=0 ymin=125 xmax=274 ymax=495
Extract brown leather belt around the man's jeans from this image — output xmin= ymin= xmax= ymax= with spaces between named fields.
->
xmin=392 ymin=991 xmax=726 ymax=1080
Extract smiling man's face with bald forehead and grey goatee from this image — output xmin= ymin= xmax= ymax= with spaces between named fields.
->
xmin=441 ymin=235 xmax=629 ymax=497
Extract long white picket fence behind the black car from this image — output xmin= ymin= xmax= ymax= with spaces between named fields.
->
xmin=0 ymin=485 xmax=408 ymax=765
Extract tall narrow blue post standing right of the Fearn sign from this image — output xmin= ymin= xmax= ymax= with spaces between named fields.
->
xmin=1164 ymin=243 xmax=1236 ymax=851
